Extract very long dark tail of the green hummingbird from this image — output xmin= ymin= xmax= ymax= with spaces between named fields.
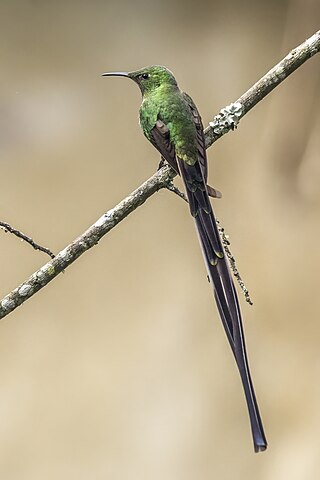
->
xmin=178 ymin=158 xmax=267 ymax=452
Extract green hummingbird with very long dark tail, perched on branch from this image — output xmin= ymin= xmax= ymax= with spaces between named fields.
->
xmin=102 ymin=65 xmax=267 ymax=452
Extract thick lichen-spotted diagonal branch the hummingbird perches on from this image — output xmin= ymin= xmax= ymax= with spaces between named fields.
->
xmin=0 ymin=30 xmax=320 ymax=318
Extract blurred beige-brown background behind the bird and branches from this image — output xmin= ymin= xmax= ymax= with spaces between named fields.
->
xmin=0 ymin=0 xmax=320 ymax=480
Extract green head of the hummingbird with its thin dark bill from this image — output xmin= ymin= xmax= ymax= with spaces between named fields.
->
xmin=102 ymin=65 xmax=177 ymax=95
